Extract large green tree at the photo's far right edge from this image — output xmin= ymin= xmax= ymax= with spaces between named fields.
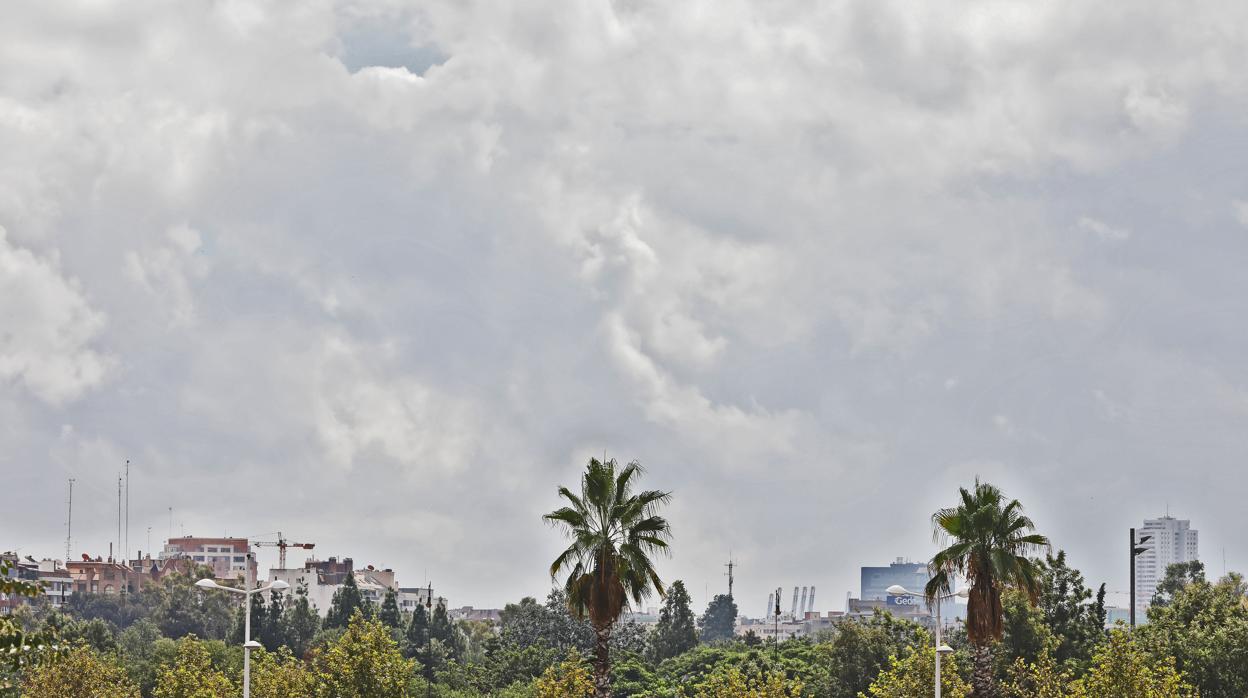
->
xmin=1136 ymin=573 xmax=1248 ymax=698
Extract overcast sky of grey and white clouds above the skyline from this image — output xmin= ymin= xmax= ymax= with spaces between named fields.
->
xmin=0 ymin=0 xmax=1248 ymax=614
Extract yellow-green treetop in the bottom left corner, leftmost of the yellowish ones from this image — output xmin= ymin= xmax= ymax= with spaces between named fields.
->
xmin=21 ymin=644 xmax=140 ymax=698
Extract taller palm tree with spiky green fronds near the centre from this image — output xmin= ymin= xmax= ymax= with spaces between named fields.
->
xmin=542 ymin=458 xmax=671 ymax=698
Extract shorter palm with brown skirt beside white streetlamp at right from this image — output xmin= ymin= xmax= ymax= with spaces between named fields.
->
xmin=924 ymin=478 xmax=1048 ymax=698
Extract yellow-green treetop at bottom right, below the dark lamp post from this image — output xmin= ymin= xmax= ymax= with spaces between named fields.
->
xmin=1071 ymin=629 xmax=1193 ymax=698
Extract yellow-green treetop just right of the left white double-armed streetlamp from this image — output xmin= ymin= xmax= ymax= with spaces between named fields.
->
xmin=312 ymin=609 xmax=416 ymax=698
